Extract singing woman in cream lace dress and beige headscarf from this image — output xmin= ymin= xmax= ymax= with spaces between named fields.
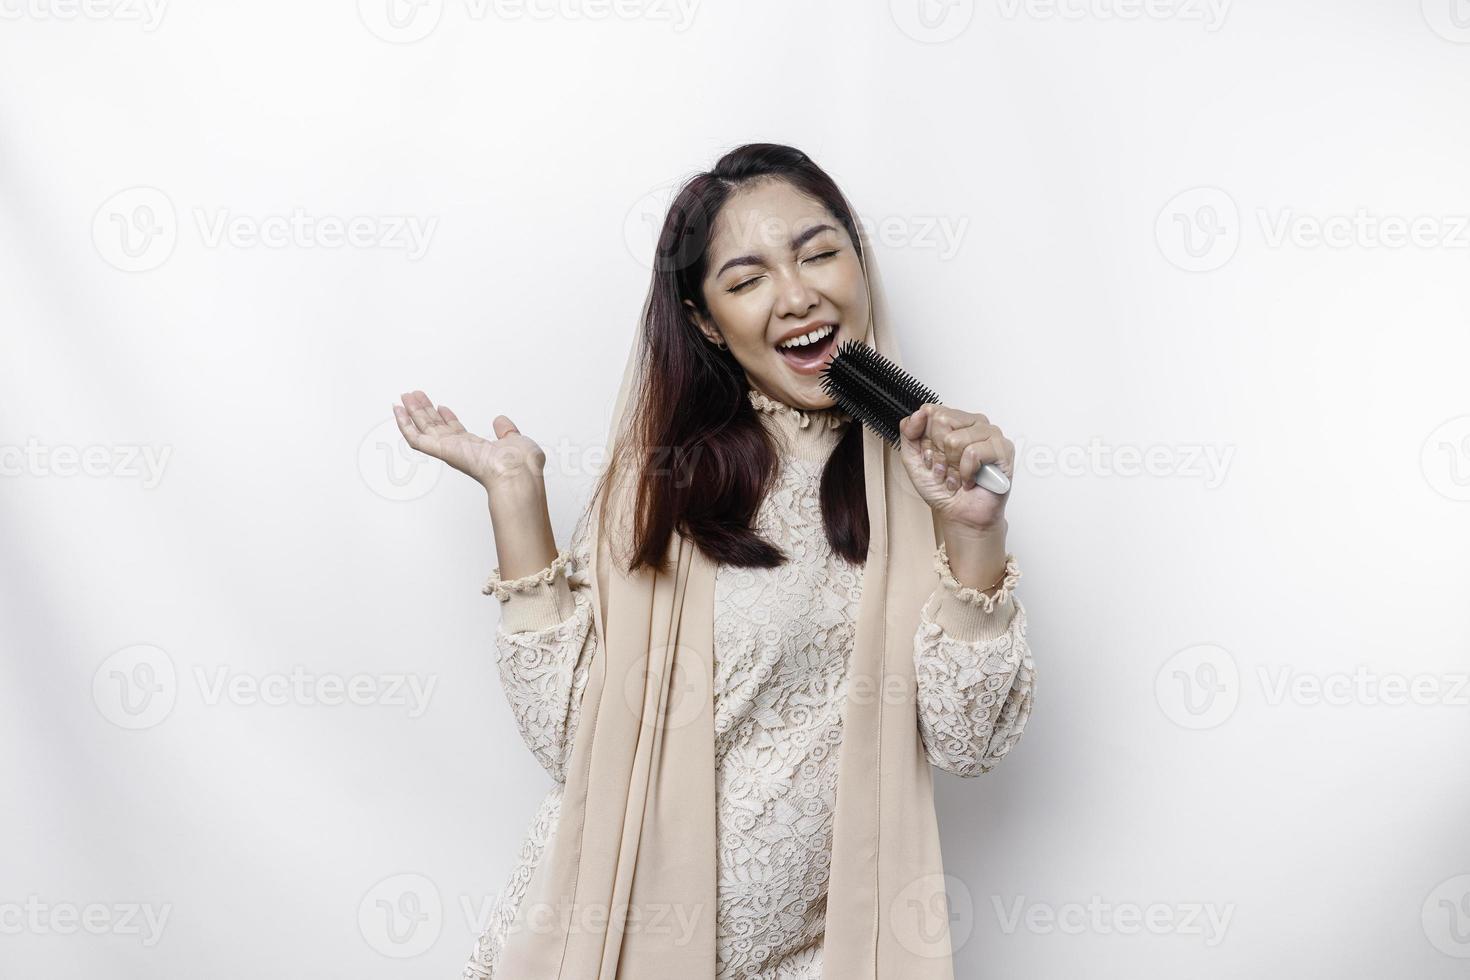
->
xmin=394 ymin=144 xmax=1035 ymax=980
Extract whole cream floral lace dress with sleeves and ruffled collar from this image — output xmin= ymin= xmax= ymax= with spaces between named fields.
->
xmin=463 ymin=391 xmax=1035 ymax=980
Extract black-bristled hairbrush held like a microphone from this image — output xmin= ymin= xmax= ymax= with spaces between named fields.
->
xmin=822 ymin=339 xmax=1010 ymax=494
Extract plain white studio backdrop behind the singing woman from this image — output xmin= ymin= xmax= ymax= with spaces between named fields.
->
xmin=0 ymin=0 xmax=1470 ymax=980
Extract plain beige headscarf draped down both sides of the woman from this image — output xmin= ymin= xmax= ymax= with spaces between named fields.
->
xmin=497 ymin=224 xmax=954 ymax=980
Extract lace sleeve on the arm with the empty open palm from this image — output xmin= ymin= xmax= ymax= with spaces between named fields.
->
xmin=484 ymin=517 xmax=598 ymax=783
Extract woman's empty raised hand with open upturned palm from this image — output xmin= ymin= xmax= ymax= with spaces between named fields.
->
xmin=392 ymin=391 xmax=547 ymax=491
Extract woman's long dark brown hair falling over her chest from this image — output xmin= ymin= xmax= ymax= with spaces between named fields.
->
xmin=589 ymin=143 xmax=869 ymax=573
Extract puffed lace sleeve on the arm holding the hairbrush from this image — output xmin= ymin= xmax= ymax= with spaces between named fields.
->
xmin=914 ymin=545 xmax=1036 ymax=776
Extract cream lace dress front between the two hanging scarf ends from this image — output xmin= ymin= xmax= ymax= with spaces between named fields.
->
xmin=714 ymin=458 xmax=863 ymax=980
